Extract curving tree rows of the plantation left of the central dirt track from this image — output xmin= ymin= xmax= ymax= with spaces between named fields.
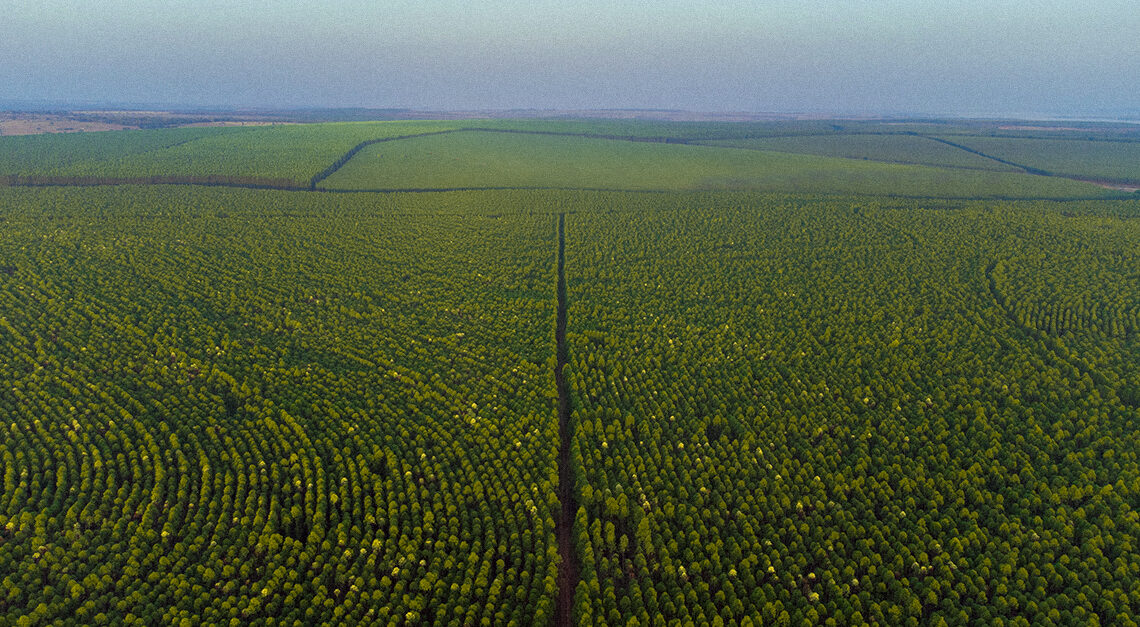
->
xmin=0 ymin=187 xmax=559 ymax=625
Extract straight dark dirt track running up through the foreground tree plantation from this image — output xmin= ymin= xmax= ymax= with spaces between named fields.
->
xmin=554 ymin=213 xmax=578 ymax=627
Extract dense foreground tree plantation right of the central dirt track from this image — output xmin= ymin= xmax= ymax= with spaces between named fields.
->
xmin=567 ymin=198 xmax=1140 ymax=625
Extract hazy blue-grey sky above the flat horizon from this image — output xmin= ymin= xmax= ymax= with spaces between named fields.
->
xmin=0 ymin=0 xmax=1140 ymax=115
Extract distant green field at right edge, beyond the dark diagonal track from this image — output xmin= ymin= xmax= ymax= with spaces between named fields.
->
xmin=930 ymin=136 xmax=1140 ymax=182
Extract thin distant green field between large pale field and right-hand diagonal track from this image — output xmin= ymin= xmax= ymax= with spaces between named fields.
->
xmin=705 ymin=133 xmax=1017 ymax=172
